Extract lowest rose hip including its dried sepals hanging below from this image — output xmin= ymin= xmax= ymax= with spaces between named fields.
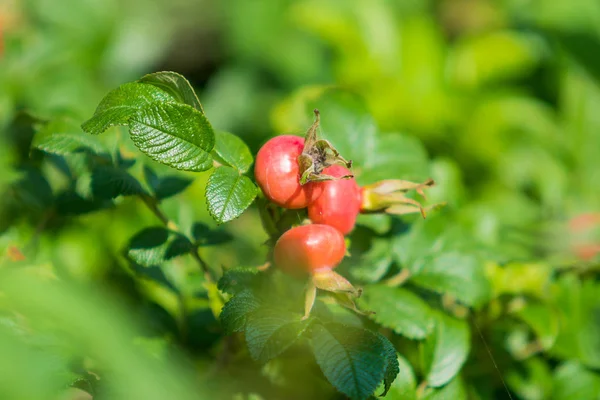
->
xmin=273 ymin=224 xmax=361 ymax=317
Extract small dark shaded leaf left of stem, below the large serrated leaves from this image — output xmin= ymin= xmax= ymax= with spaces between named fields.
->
xmin=91 ymin=166 xmax=144 ymax=199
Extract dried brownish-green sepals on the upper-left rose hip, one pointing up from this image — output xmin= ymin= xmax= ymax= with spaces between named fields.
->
xmin=298 ymin=109 xmax=354 ymax=185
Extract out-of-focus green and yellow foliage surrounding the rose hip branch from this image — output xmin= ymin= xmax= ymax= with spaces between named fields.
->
xmin=0 ymin=0 xmax=600 ymax=400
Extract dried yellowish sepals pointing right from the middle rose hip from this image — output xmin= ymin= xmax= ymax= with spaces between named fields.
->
xmin=360 ymin=179 xmax=445 ymax=218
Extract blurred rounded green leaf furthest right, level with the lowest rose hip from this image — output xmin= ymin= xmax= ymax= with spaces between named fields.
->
xmin=411 ymin=252 xmax=490 ymax=306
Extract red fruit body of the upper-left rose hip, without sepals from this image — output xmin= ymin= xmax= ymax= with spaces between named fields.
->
xmin=254 ymin=135 xmax=322 ymax=209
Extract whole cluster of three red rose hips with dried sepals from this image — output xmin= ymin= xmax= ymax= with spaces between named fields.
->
xmin=254 ymin=110 xmax=433 ymax=315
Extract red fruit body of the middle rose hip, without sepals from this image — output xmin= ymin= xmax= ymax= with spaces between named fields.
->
xmin=308 ymin=165 xmax=362 ymax=235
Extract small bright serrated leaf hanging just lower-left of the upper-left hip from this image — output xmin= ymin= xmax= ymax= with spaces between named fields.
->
xmin=206 ymin=167 xmax=258 ymax=224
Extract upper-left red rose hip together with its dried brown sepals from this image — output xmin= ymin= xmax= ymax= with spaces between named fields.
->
xmin=254 ymin=110 xmax=352 ymax=209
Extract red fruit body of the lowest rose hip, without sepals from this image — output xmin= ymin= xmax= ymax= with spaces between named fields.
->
xmin=273 ymin=224 xmax=346 ymax=276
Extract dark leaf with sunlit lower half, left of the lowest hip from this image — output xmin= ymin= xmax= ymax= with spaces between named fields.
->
xmin=127 ymin=227 xmax=192 ymax=267
